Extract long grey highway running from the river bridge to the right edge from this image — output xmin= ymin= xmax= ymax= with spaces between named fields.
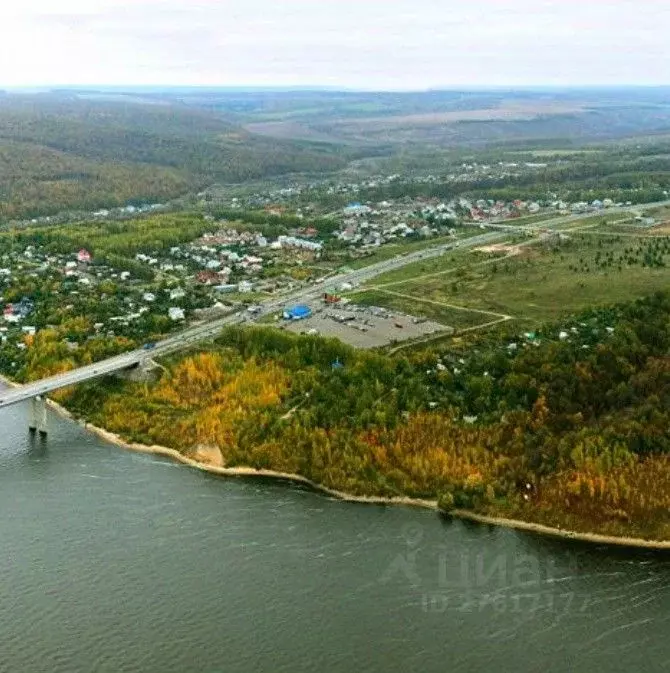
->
xmin=0 ymin=201 xmax=670 ymax=409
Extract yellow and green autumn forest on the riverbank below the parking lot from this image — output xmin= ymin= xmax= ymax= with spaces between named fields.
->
xmin=60 ymin=293 xmax=670 ymax=539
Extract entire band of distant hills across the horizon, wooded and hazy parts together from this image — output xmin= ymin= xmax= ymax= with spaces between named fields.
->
xmin=6 ymin=87 xmax=670 ymax=219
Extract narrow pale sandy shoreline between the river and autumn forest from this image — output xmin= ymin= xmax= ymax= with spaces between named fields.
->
xmin=0 ymin=375 xmax=670 ymax=550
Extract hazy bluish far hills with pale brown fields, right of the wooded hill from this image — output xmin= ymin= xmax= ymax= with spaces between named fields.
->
xmin=231 ymin=88 xmax=670 ymax=148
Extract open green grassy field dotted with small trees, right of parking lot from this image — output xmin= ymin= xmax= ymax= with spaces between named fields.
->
xmin=357 ymin=233 xmax=670 ymax=328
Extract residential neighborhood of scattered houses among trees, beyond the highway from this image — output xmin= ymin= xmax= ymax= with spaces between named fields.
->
xmin=0 ymin=163 xmax=668 ymax=376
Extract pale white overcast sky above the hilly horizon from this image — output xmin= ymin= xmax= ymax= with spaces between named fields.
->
xmin=0 ymin=0 xmax=670 ymax=89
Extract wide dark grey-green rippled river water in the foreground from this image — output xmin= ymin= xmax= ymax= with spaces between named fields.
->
xmin=0 ymin=394 xmax=670 ymax=673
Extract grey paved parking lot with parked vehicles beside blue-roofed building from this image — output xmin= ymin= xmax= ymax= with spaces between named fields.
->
xmin=280 ymin=304 xmax=452 ymax=348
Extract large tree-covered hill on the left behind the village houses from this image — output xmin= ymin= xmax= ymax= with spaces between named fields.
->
xmin=0 ymin=94 xmax=346 ymax=218
